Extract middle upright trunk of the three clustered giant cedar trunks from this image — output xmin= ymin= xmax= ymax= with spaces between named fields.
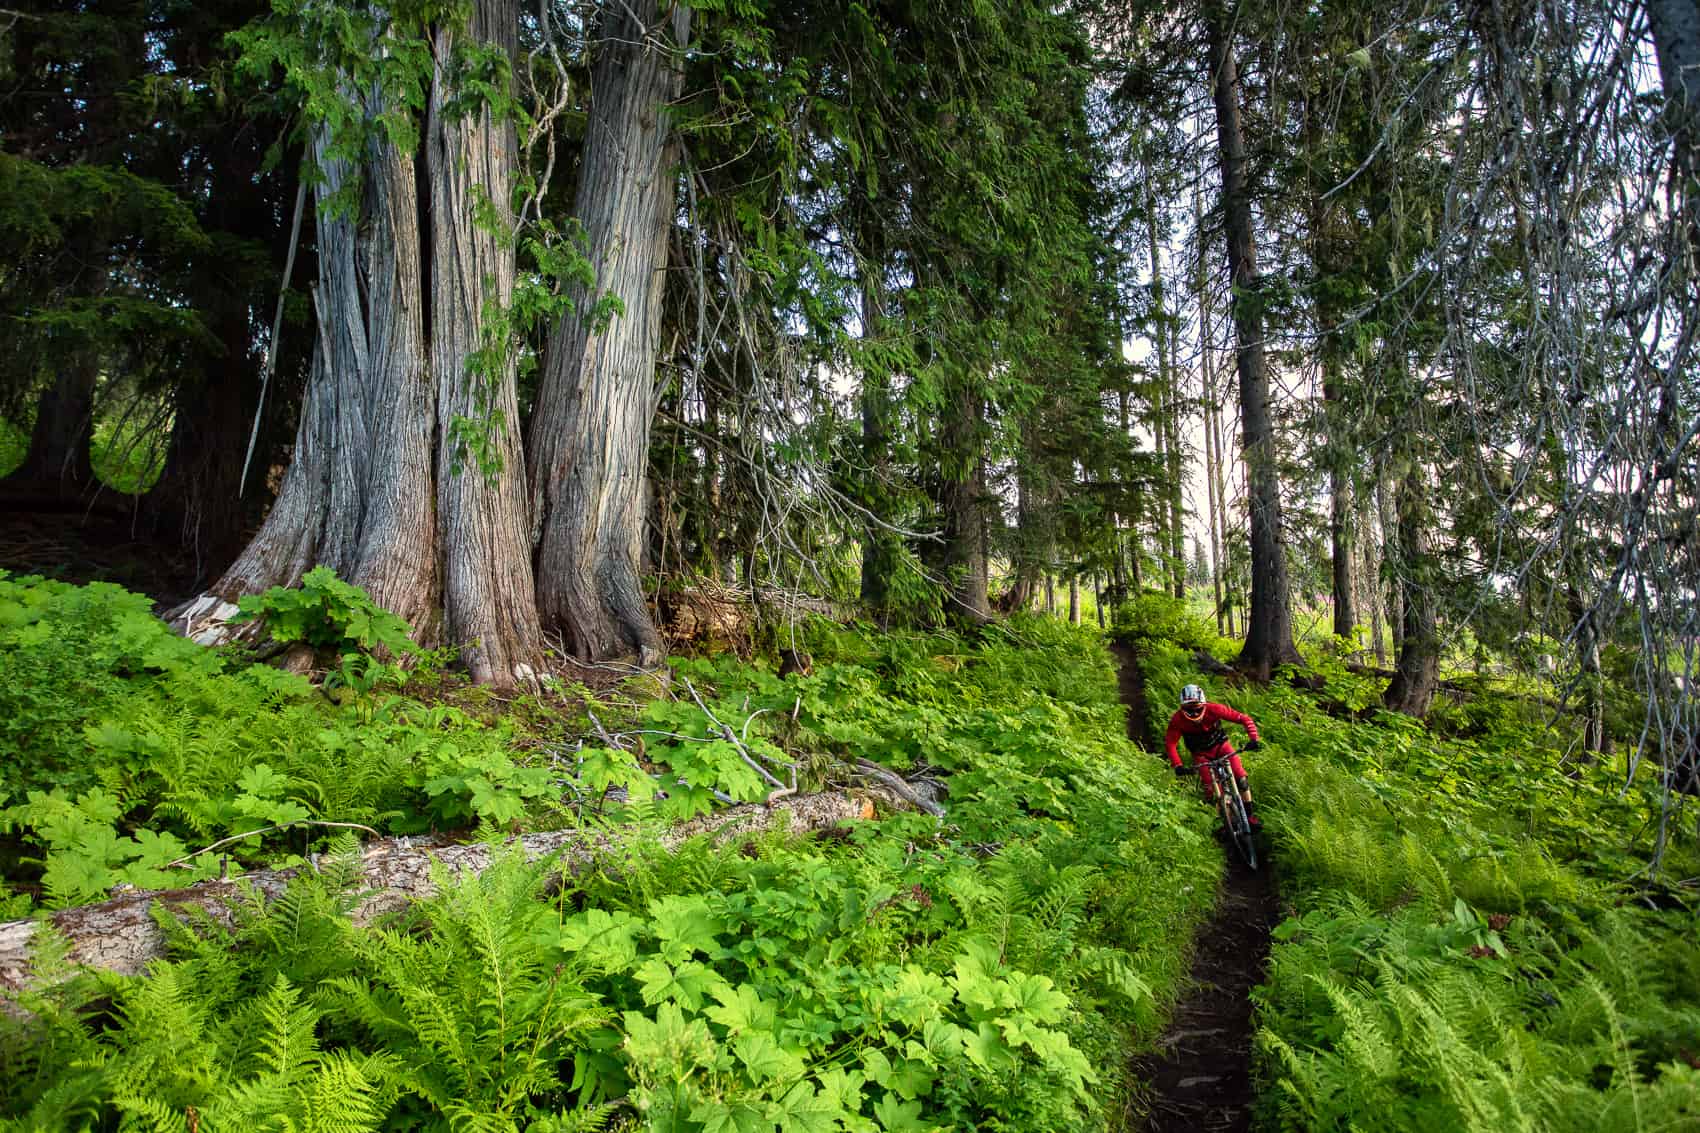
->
xmin=427 ymin=0 xmax=537 ymax=684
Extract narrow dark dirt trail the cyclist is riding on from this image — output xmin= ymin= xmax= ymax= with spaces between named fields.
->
xmin=1112 ymin=645 xmax=1280 ymax=1133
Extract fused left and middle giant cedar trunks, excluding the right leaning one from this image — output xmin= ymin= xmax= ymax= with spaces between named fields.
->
xmin=173 ymin=0 xmax=541 ymax=686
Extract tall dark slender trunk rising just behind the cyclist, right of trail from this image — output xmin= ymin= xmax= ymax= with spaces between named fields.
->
xmin=1205 ymin=5 xmax=1302 ymax=680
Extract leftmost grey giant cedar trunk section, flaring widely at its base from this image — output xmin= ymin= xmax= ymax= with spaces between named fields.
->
xmin=173 ymin=85 xmax=438 ymax=643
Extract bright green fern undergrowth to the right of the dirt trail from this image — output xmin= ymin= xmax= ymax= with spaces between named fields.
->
xmin=1146 ymin=636 xmax=1700 ymax=1133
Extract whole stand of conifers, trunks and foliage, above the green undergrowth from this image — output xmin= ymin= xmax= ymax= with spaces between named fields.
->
xmin=0 ymin=0 xmax=1700 ymax=826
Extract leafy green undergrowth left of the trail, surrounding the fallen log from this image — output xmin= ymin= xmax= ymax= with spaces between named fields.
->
xmin=0 ymin=582 xmax=1219 ymax=1131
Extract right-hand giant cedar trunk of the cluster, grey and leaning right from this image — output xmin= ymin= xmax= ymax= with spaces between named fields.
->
xmin=527 ymin=3 xmax=690 ymax=669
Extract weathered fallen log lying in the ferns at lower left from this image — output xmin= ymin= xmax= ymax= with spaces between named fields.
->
xmin=0 ymin=788 xmax=908 ymax=994
